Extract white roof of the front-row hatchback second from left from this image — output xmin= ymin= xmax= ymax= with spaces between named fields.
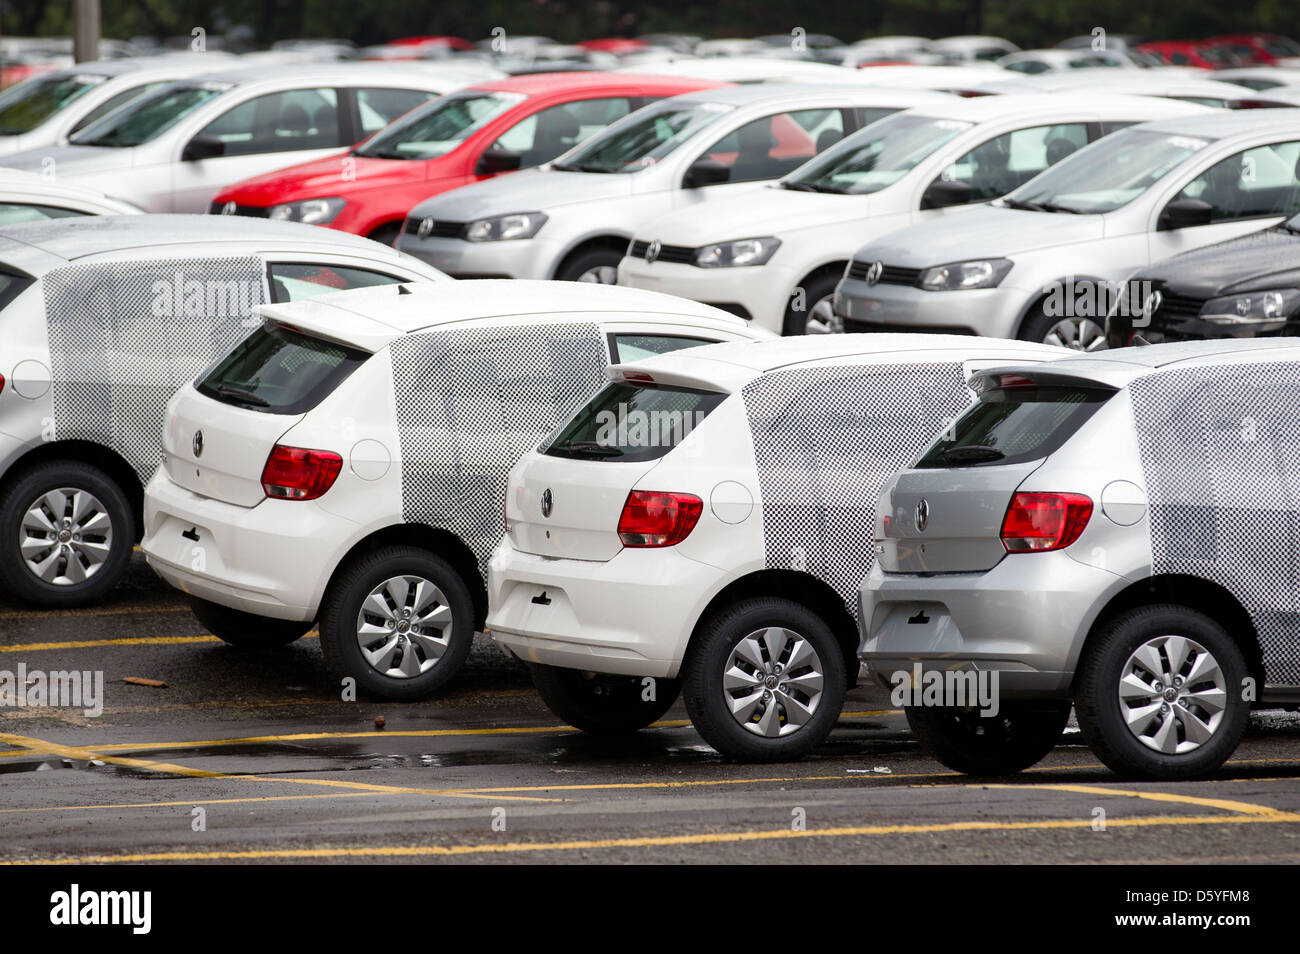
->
xmin=259 ymin=278 xmax=748 ymax=342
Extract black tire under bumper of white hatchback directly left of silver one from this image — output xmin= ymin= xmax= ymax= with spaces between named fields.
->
xmin=529 ymin=664 xmax=681 ymax=736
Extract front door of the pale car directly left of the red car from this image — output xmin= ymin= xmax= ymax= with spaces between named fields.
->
xmin=170 ymin=87 xmax=350 ymax=212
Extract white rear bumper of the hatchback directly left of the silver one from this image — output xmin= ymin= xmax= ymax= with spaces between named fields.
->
xmin=488 ymin=538 xmax=718 ymax=678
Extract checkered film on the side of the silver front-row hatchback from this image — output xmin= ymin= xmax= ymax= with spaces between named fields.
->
xmin=1130 ymin=363 xmax=1300 ymax=686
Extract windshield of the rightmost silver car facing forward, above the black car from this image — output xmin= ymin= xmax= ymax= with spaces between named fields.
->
xmin=1004 ymin=130 xmax=1209 ymax=213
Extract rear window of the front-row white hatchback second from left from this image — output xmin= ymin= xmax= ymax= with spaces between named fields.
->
xmin=195 ymin=324 xmax=369 ymax=415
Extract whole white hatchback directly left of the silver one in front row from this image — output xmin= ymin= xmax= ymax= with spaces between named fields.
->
xmin=488 ymin=335 xmax=1069 ymax=762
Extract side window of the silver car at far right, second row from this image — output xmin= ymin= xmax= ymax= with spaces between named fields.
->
xmin=1174 ymin=142 xmax=1300 ymax=222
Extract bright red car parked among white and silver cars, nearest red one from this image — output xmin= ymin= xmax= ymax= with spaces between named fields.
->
xmin=209 ymin=73 xmax=725 ymax=244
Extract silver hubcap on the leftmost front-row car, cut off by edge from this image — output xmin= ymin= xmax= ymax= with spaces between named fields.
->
xmin=18 ymin=487 xmax=113 ymax=586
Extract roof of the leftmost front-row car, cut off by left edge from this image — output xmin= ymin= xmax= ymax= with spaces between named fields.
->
xmin=0 ymin=214 xmax=399 ymax=270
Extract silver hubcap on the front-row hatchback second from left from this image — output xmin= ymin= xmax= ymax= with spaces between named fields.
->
xmin=356 ymin=576 xmax=452 ymax=678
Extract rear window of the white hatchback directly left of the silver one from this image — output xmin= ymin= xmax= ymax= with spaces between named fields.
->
xmin=542 ymin=381 xmax=727 ymax=463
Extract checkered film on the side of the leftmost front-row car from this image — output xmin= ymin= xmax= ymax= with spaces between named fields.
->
xmin=43 ymin=257 xmax=265 ymax=481
